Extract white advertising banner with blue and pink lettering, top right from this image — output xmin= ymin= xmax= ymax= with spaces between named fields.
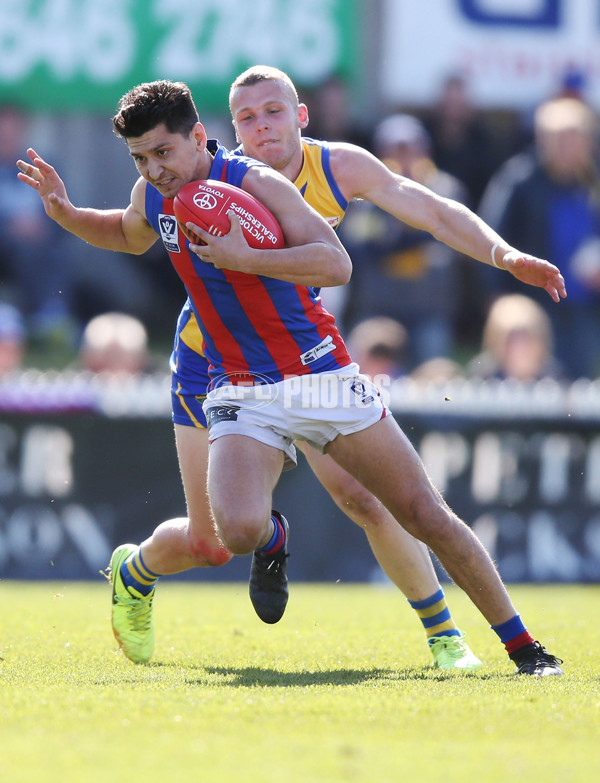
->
xmin=381 ymin=0 xmax=600 ymax=109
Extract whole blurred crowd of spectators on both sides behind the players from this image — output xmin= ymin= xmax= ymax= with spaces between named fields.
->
xmin=0 ymin=64 xmax=600 ymax=382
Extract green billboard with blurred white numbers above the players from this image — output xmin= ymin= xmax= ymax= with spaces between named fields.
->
xmin=0 ymin=0 xmax=361 ymax=111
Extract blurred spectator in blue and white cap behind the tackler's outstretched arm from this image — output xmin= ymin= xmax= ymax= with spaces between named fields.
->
xmin=340 ymin=114 xmax=466 ymax=369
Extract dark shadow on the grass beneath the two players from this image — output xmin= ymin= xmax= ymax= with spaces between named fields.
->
xmin=199 ymin=666 xmax=395 ymax=688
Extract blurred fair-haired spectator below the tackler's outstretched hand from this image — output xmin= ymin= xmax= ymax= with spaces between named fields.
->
xmin=467 ymin=294 xmax=564 ymax=382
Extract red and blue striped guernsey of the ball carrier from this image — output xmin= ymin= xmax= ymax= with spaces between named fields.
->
xmin=146 ymin=140 xmax=351 ymax=383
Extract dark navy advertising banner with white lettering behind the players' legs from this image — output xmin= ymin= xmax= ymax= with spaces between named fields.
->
xmin=0 ymin=404 xmax=600 ymax=582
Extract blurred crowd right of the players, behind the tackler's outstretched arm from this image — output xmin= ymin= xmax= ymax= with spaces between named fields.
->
xmin=318 ymin=69 xmax=600 ymax=382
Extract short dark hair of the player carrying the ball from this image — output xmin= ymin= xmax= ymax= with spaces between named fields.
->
xmin=113 ymin=79 xmax=199 ymax=138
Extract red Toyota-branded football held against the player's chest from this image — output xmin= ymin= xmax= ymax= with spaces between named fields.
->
xmin=173 ymin=179 xmax=285 ymax=248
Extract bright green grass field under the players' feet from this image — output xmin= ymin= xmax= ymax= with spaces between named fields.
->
xmin=0 ymin=580 xmax=600 ymax=783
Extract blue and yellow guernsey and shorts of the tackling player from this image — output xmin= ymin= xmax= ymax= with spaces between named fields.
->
xmin=170 ymin=138 xmax=348 ymax=428
